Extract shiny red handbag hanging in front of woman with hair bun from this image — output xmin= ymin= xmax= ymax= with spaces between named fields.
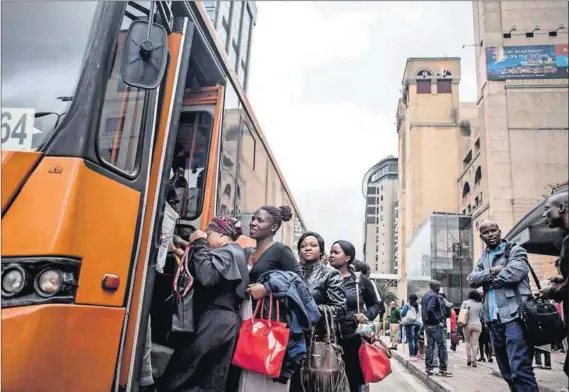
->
xmin=231 ymin=295 xmax=290 ymax=378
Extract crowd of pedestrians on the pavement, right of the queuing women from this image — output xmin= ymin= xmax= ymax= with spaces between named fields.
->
xmin=389 ymin=192 xmax=569 ymax=392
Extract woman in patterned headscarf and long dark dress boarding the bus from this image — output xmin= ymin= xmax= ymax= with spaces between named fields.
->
xmin=158 ymin=217 xmax=249 ymax=392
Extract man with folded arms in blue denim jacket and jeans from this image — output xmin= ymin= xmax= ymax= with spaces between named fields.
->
xmin=467 ymin=220 xmax=538 ymax=392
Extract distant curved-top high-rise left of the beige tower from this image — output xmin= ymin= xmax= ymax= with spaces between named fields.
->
xmin=362 ymin=156 xmax=397 ymax=274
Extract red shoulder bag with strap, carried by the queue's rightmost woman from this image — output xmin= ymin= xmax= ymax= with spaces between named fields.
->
xmin=356 ymin=279 xmax=391 ymax=384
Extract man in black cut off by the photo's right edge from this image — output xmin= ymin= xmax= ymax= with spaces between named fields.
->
xmin=540 ymin=192 xmax=569 ymax=388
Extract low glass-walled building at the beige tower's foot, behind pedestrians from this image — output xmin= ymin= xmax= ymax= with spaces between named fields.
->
xmin=406 ymin=212 xmax=473 ymax=307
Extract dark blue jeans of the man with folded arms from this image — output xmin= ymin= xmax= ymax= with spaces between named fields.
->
xmin=489 ymin=320 xmax=538 ymax=392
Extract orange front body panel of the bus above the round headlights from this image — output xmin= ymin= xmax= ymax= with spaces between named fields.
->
xmin=2 ymin=157 xmax=140 ymax=307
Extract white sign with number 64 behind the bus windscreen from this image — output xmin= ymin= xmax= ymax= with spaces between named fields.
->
xmin=1 ymin=108 xmax=35 ymax=151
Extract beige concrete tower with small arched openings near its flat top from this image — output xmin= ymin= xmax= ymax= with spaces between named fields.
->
xmin=396 ymin=58 xmax=461 ymax=298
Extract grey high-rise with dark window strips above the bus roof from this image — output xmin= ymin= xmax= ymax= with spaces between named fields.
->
xmin=204 ymin=0 xmax=257 ymax=91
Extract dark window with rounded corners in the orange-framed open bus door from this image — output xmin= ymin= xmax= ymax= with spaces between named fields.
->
xmin=170 ymin=112 xmax=213 ymax=220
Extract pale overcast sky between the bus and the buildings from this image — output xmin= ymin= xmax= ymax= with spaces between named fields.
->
xmin=248 ymin=1 xmax=476 ymax=257
